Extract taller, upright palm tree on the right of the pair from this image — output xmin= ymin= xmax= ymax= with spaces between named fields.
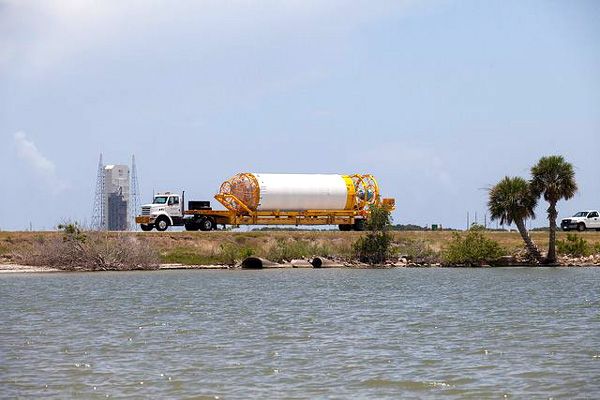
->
xmin=530 ymin=156 xmax=577 ymax=264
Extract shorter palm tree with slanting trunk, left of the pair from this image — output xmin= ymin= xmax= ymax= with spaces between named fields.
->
xmin=488 ymin=176 xmax=543 ymax=262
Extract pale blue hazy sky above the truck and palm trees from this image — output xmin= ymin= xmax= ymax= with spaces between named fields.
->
xmin=0 ymin=0 xmax=600 ymax=230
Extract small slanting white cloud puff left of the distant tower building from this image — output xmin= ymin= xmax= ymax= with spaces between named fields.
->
xmin=14 ymin=132 xmax=67 ymax=194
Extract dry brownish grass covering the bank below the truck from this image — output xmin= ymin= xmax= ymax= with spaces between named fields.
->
xmin=0 ymin=231 xmax=600 ymax=265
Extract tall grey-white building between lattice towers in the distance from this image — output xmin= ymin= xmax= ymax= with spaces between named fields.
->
xmin=102 ymin=165 xmax=130 ymax=231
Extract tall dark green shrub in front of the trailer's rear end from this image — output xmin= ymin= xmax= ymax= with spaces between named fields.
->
xmin=353 ymin=205 xmax=392 ymax=265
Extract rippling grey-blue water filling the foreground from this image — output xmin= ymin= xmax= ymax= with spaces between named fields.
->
xmin=0 ymin=268 xmax=600 ymax=399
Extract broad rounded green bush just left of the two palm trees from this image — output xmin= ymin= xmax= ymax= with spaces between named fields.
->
xmin=442 ymin=228 xmax=504 ymax=265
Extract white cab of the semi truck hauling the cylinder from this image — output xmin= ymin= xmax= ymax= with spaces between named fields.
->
xmin=138 ymin=192 xmax=183 ymax=231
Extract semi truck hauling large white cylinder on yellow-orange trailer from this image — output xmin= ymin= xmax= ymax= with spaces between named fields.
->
xmin=135 ymin=172 xmax=395 ymax=231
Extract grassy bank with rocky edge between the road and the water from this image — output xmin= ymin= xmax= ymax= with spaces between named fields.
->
xmin=0 ymin=231 xmax=600 ymax=273
